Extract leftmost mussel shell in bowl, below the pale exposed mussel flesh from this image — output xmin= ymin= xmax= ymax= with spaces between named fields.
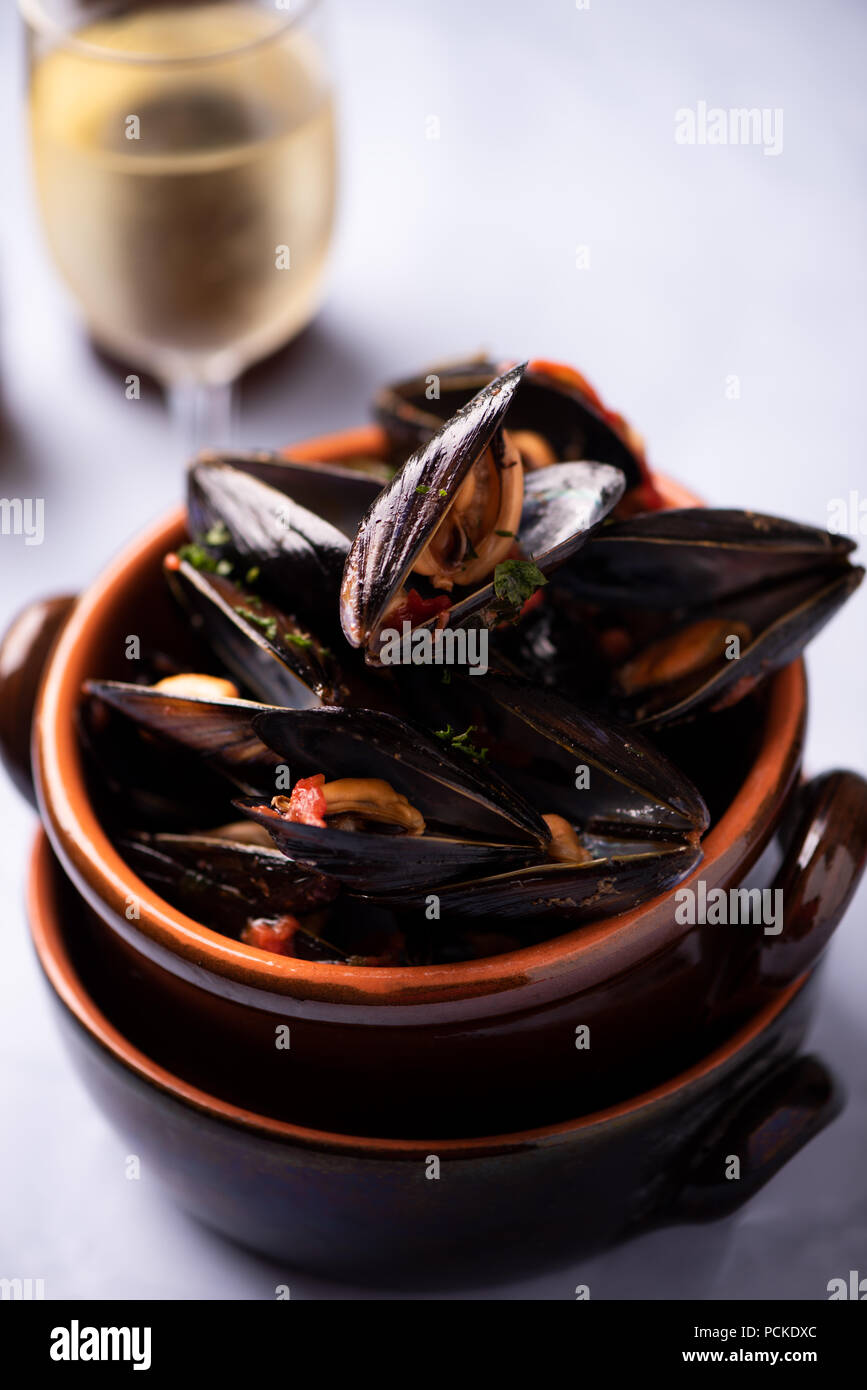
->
xmin=85 ymin=681 xmax=281 ymax=795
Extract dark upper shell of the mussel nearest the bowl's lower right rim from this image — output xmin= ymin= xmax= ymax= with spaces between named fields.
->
xmin=454 ymin=674 xmax=710 ymax=840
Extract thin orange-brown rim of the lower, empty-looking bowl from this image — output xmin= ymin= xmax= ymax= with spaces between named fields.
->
xmin=26 ymin=827 xmax=811 ymax=1161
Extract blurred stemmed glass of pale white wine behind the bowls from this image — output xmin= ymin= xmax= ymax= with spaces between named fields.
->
xmin=19 ymin=0 xmax=335 ymax=448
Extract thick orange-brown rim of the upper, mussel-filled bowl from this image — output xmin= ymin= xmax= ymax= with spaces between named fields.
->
xmin=33 ymin=425 xmax=806 ymax=1005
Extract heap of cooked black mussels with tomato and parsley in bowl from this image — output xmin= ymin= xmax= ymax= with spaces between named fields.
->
xmin=81 ymin=360 xmax=863 ymax=966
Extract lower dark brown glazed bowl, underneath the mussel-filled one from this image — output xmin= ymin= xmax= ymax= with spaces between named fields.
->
xmin=28 ymin=834 xmax=839 ymax=1287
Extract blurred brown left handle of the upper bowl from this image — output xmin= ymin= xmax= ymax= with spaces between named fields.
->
xmin=0 ymin=594 xmax=75 ymax=808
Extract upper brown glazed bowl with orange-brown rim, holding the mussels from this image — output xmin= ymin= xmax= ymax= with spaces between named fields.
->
xmin=0 ymin=428 xmax=867 ymax=1136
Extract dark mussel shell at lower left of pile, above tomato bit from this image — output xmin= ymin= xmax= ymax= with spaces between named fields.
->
xmin=118 ymin=827 xmax=339 ymax=935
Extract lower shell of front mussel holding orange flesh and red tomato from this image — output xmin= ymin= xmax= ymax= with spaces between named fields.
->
xmin=235 ymin=801 xmax=542 ymax=897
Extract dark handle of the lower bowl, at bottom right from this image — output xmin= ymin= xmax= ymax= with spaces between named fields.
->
xmin=661 ymin=1056 xmax=842 ymax=1225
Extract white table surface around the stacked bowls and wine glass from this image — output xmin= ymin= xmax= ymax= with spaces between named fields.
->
xmin=0 ymin=0 xmax=867 ymax=1300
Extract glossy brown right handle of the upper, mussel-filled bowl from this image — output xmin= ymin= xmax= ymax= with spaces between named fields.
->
xmin=759 ymin=771 xmax=867 ymax=988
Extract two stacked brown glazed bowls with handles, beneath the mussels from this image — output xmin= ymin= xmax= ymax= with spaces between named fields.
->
xmin=0 ymin=405 xmax=867 ymax=1280
